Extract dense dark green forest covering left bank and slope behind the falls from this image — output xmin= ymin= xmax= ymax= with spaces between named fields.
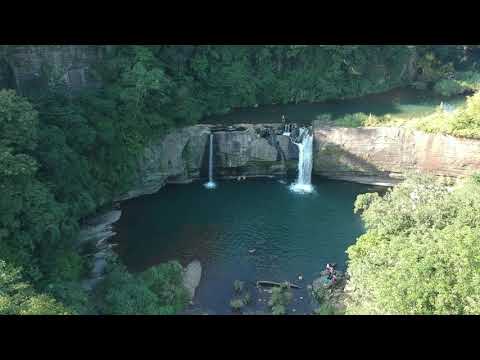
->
xmin=0 ymin=45 xmax=479 ymax=314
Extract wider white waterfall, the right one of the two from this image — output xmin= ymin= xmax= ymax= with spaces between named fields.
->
xmin=290 ymin=127 xmax=313 ymax=193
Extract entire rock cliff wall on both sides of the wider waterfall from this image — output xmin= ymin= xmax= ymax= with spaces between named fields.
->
xmin=117 ymin=122 xmax=480 ymax=201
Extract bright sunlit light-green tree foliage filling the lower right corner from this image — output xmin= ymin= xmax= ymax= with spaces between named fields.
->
xmin=347 ymin=177 xmax=480 ymax=314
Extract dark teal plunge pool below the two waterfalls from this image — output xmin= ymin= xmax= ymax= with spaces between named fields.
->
xmin=113 ymin=178 xmax=378 ymax=314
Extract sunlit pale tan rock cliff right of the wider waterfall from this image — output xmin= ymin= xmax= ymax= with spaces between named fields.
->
xmin=313 ymin=122 xmax=480 ymax=185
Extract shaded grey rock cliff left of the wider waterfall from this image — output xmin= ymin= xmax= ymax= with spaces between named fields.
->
xmin=117 ymin=124 xmax=298 ymax=201
